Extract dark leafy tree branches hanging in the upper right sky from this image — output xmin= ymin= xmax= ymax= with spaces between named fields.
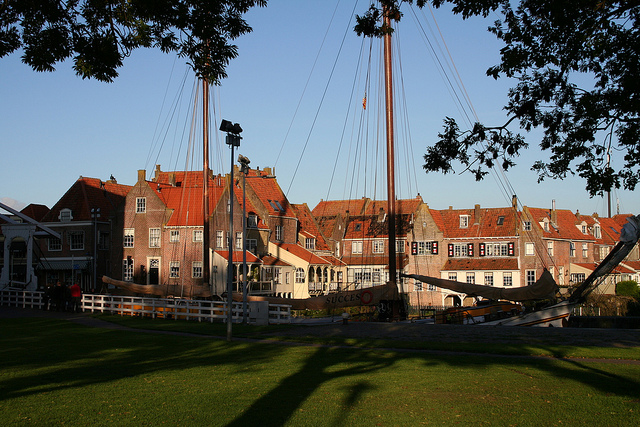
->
xmin=355 ymin=0 xmax=640 ymax=196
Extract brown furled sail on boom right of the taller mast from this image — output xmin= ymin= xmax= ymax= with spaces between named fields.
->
xmin=400 ymin=269 xmax=558 ymax=301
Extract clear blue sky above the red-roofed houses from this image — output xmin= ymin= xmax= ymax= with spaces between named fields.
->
xmin=0 ymin=0 xmax=640 ymax=215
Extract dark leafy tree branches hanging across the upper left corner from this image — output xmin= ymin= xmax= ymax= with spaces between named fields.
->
xmin=0 ymin=0 xmax=267 ymax=83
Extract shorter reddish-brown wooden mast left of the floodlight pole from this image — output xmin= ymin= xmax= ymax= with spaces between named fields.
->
xmin=202 ymin=77 xmax=210 ymax=286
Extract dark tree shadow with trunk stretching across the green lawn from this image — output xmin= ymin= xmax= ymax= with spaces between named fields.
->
xmin=0 ymin=318 xmax=640 ymax=427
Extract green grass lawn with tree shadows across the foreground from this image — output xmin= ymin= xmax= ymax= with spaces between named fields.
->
xmin=0 ymin=318 xmax=640 ymax=426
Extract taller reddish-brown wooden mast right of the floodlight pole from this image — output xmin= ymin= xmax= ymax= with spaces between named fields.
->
xmin=382 ymin=6 xmax=397 ymax=284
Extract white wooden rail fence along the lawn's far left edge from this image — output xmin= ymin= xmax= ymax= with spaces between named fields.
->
xmin=0 ymin=290 xmax=291 ymax=324
